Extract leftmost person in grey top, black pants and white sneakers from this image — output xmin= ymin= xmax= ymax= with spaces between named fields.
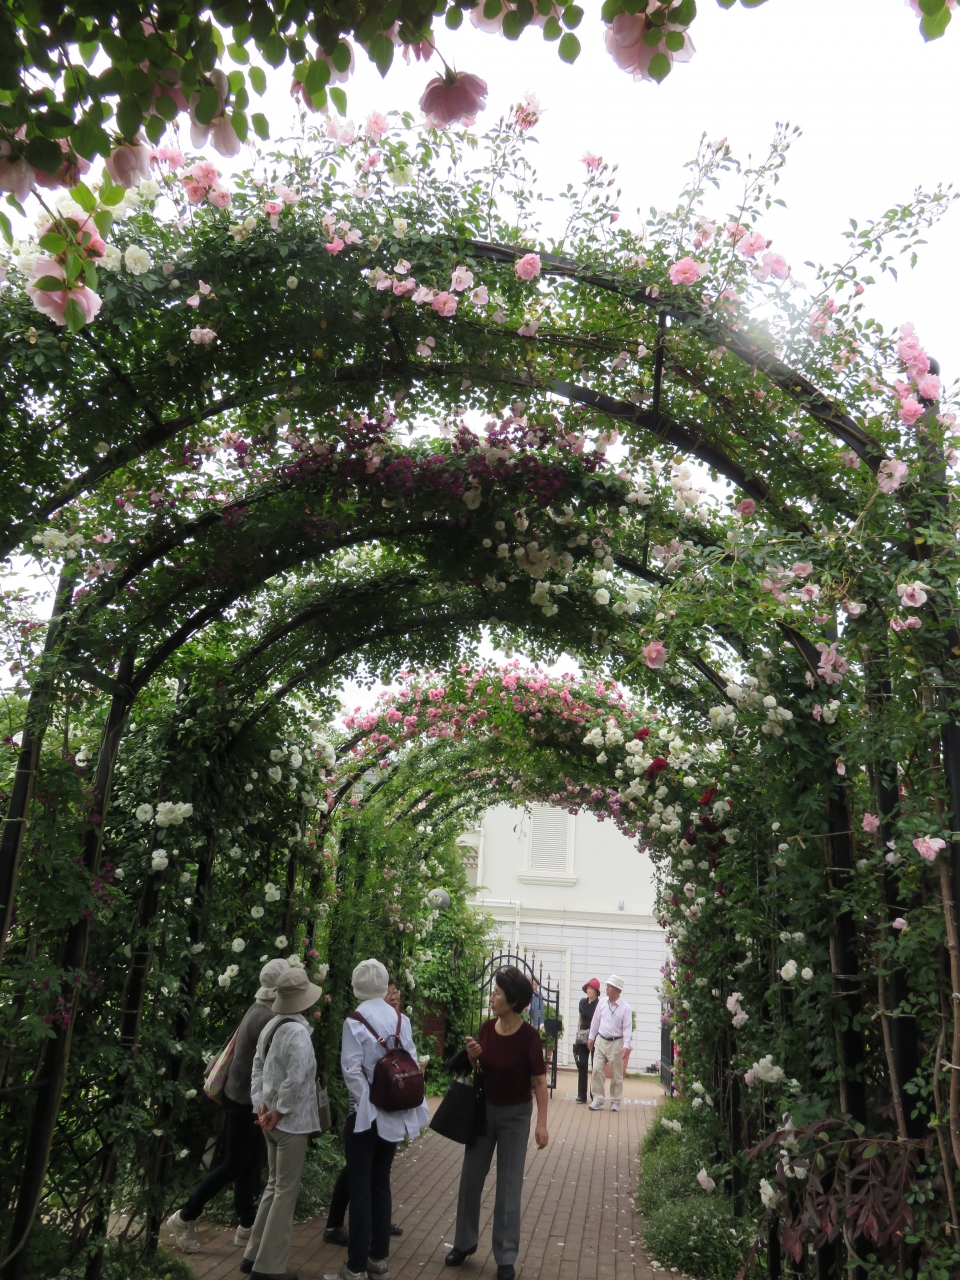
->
xmin=166 ymin=959 xmax=289 ymax=1253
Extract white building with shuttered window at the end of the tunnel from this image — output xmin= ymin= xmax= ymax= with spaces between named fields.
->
xmin=460 ymin=804 xmax=666 ymax=1071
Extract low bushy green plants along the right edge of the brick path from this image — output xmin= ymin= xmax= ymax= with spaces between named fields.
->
xmin=637 ymin=1100 xmax=756 ymax=1280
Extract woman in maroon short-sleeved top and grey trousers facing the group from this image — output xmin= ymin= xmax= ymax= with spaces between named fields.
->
xmin=444 ymin=965 xmax=549 ymax=1280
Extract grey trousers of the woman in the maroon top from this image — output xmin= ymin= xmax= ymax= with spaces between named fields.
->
xmin=453 ymin=1102 xmax=534 ymax=1266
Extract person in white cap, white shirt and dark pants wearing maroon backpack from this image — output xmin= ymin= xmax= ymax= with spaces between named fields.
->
xmin=324 ymin=960 xmax=430 ymax=1280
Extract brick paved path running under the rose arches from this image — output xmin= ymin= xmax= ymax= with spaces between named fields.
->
xmin=179 ymin=1071 xmax=663 ymax=1280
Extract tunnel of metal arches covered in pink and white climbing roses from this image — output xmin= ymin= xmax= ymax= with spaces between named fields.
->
xmin=0 ymin=116 xmax=960 ymax=1280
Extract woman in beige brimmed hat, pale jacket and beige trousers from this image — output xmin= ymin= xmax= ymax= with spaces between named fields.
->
xmin=241 ymin=968 xmax=323 ymax=1280
